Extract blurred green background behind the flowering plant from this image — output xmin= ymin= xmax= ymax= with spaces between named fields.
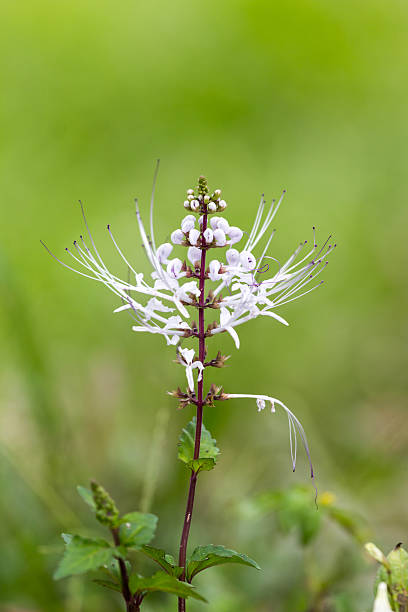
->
xmin=0 ymin=0 xmax=408 ymax=612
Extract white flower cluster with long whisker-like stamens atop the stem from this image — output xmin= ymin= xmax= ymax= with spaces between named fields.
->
xmin=44 ymin=182 xmax=336 ymax=478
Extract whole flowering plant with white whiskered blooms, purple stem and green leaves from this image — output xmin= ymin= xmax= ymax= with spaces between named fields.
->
xmin=44 ymin=169 xmax=336 ymax=612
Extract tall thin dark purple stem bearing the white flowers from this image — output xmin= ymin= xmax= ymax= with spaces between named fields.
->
xmin=178 ymin=206 xmax=207 ymax=612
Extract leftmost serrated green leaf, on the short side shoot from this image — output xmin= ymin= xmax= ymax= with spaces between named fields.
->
xmin=54 ymin=535 xmax=120 ymax=580
